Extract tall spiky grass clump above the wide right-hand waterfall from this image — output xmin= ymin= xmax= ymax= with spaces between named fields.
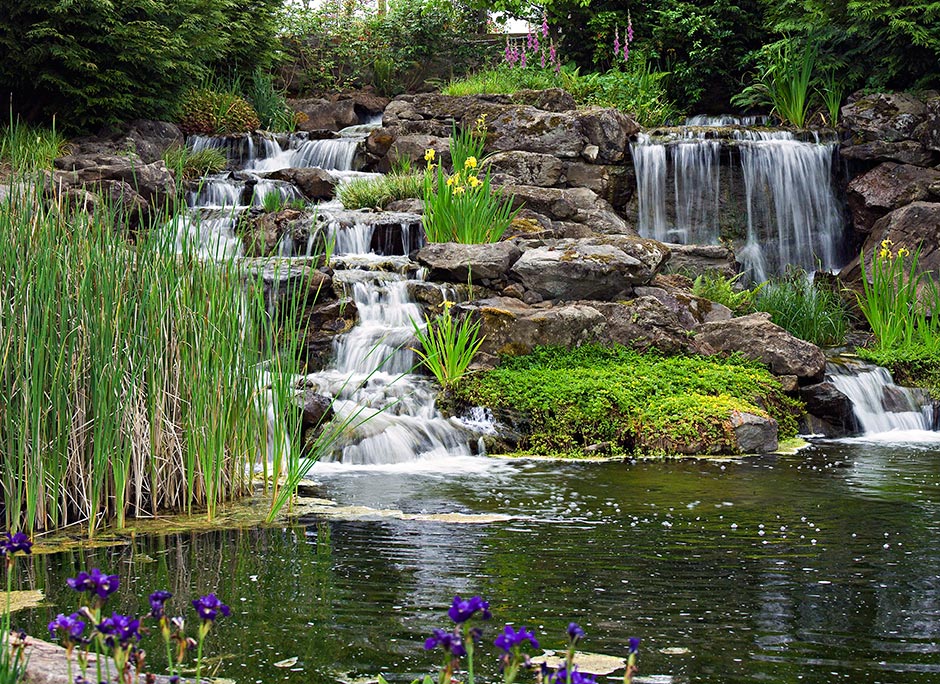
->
xmin=731 ymin=38 xmax=820 ymax=128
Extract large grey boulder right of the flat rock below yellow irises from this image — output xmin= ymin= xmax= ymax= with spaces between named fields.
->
xmin=512 ymin=237 xmax=668 ymax=301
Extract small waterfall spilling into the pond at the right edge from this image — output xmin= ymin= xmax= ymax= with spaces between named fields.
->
xmin=827 ymin=361 xmax=934 ymax=435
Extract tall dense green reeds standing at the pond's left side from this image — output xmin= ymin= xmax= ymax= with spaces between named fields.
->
xmin=0 ymin=183 xmax=302 ymax=534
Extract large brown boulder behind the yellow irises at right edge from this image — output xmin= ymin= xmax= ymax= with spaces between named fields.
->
xmin=839 ymin=202 xmax=940 ymax=284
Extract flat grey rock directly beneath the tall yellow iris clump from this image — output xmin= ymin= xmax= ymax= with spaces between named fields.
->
xmin=415 ymin=242 xmax=522 ymax=283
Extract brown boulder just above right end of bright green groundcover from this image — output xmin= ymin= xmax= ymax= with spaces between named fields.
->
xmin=695 ymin=312 xmax=826 ymax=384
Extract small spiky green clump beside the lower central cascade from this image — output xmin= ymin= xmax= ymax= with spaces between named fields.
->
xmin=411 ymin=301 xmax=483 ymax=390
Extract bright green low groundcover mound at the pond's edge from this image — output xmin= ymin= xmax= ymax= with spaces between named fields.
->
xmin=456 ymin=345 xmax=799 ymax=453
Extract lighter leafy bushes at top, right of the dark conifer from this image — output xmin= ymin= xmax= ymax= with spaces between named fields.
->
xmin=283 ymin=0 xmax=481 ymax=95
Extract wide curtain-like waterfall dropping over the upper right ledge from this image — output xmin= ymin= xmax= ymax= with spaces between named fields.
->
xmin=631 ymin=123 xmax=844 ymax=281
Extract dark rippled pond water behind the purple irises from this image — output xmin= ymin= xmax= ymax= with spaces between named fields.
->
xmin=17 ymin=441 xmax=940 ymax=684
